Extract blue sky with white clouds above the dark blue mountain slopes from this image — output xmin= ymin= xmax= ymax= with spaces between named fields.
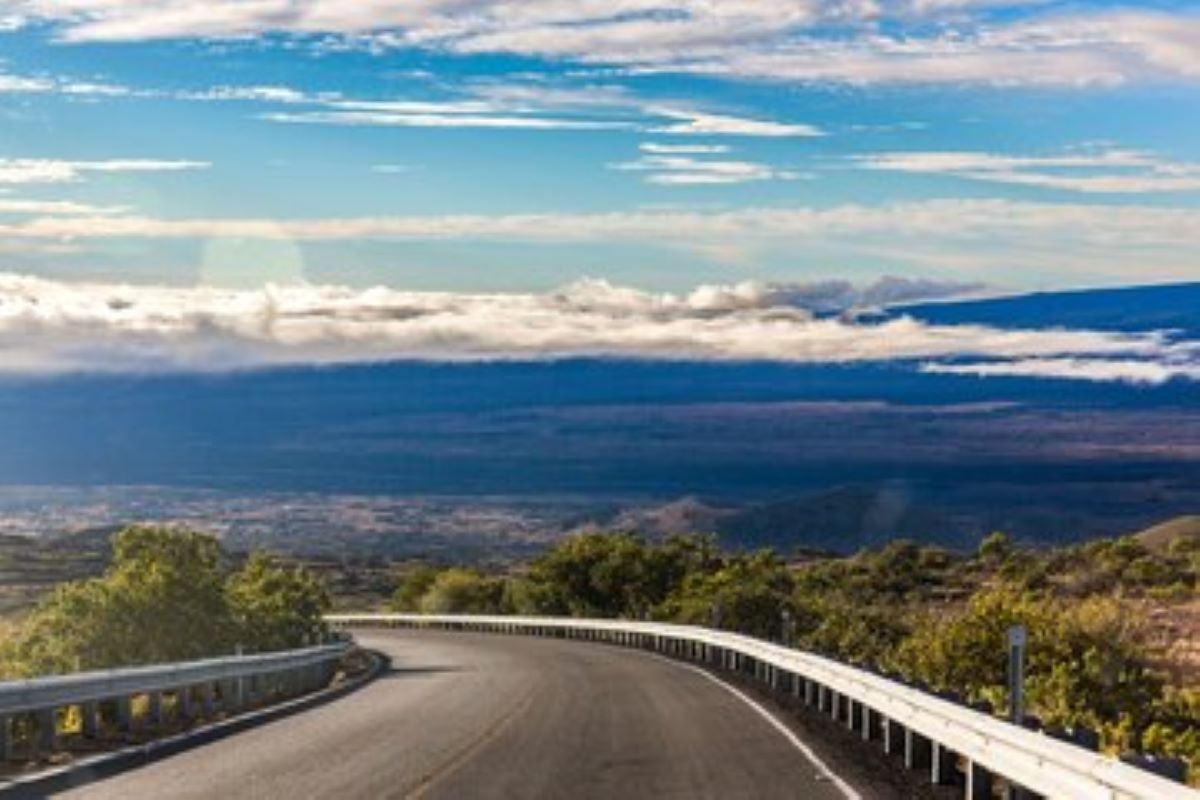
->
xmin=0 ymin=0 xmax=1200 ymax=377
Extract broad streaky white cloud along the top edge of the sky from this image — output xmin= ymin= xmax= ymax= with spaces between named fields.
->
xmin=0 ymin=0 xmax=1200 ymax=86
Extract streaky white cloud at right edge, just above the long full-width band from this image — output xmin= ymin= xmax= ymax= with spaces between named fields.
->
xmin=853 ymin=148 xmax=1200 ymax=194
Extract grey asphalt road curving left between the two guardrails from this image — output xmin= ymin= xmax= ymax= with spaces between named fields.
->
xmin=62 ymin=631 xmax=852 ymax=800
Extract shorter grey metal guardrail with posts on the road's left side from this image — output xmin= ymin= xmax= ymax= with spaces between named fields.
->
xmin=0 ymin=642 xmax=350 ymax=760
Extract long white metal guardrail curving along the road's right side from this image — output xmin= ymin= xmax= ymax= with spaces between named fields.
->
xmin=326 ymin=614 xmax=1200 ymax=800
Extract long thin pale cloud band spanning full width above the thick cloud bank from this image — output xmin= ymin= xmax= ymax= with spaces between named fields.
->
xmin=0 ymin=196 xmax=1200 ymax=247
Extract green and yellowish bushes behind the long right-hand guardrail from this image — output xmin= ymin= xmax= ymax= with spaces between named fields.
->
xmin=392 ymin=533 xmax=1200 ymax=778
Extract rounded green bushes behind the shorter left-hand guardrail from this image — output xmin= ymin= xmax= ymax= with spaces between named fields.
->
xmin=0 ymin=527 xmax=330 ymax=678
